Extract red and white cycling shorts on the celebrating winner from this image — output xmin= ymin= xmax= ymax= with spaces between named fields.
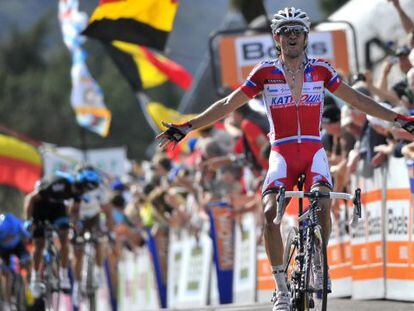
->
xmin=262 ymin=140 xmax=332 ymax=192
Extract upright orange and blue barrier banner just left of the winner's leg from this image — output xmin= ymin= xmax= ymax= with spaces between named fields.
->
xmin=208 ymin=202 xmax=234 ymax=304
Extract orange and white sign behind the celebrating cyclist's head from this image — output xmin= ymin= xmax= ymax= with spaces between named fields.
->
xmin=219 ymin=30 xmax=350 ymax=88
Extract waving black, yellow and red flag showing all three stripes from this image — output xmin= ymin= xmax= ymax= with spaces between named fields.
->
xmin=105 ymin=41 xmax=192 ymax=91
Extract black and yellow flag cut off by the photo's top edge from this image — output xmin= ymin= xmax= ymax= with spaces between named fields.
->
xmin=83 ymin=0 xmax=178 ymax=50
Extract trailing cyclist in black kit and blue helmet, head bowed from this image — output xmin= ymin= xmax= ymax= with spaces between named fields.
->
xmin=25 ymin=170 xmax=99 ymax=298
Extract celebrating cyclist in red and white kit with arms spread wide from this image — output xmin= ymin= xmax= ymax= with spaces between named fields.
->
xmin=157 ymin=7 xmax=414 ymax=311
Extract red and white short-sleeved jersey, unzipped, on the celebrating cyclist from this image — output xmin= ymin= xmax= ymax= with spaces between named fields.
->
xmin=240 ymin=58 xmax=341 ymax=145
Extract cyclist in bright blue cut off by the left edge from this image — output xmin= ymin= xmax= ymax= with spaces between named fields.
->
xmin=0 ymin=214 xmax=30 ymax=310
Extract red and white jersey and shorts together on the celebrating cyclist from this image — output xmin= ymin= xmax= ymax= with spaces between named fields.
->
xmin=240 ymin=59 xmax=341 ymax=190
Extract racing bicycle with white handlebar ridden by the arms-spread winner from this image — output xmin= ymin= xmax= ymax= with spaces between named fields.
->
xmin=278 ymin=175 xmax=361 ymax=311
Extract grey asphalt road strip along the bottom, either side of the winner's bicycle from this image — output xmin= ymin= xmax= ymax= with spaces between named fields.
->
xmin=164 ymin=299 xmax=414 ymax=311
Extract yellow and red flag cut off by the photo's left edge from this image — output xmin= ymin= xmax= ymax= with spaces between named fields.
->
xmin=0 ymin=134 xmax=42 ymax=193
